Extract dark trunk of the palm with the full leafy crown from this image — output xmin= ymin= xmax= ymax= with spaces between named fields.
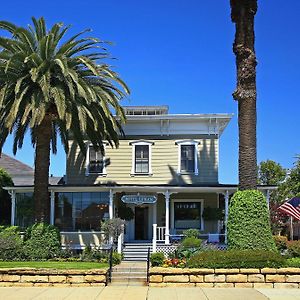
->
xmin=34 ymin=115 xmax=52 ymax=223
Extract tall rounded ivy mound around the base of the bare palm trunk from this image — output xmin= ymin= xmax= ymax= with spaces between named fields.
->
xmin=227 ymin=190 xmax=277 ymax=251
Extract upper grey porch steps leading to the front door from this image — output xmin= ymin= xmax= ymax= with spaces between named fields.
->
xmin=123 ymin=243 xmax=152 ymax=261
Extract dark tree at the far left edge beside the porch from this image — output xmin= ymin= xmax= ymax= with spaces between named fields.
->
xmin=0 ymin=168 xmax=13 ymax=224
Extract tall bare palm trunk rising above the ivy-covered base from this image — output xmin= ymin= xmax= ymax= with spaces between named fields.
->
xmin=230 ymin=0 xmax=257 ymax=190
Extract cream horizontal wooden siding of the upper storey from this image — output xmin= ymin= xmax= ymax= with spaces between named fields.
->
xmin=66 ymin=137 xmax=219 ymax=184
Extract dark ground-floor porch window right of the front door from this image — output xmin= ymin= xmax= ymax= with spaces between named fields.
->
xmin=174 ymin=201 xmax=203 ymax=230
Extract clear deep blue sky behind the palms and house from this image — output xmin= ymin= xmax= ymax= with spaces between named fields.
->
xmin=1 ymin=0 xmax=300 ymax=183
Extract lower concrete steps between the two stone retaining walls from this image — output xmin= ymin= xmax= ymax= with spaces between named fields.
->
xmin=110 ymin=262 xmax=147 ymax=286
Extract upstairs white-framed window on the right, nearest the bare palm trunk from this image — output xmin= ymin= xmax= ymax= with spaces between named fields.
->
xmin=176 ymin=140 xmax=199 ymax=175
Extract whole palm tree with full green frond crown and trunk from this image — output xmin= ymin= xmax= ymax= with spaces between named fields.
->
xmin=0 ymin=18 xmax=129 ymax=222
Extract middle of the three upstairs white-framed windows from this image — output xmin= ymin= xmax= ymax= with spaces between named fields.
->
xmin=130 ymin=141 xmax=153 ymax=176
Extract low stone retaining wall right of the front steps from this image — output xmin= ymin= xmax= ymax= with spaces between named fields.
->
xmin=149 ymin=267 xmax=300 ymax=288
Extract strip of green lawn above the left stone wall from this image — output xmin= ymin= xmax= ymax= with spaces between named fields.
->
xmin=0 ymin=261 xmax=108 ymax=270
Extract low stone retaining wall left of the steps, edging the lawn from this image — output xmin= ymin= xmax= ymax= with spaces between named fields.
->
xmin=0 ymin=268 xmax=108 ymax=287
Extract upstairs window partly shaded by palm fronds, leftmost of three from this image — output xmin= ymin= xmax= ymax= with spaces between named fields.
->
xmin=86 ymin=145 xmax=106 ymax=175
